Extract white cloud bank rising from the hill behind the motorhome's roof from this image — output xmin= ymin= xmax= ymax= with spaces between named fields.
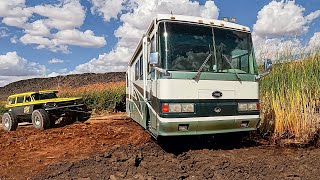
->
xmin=71 ymin=0 xmax=219 ymax=73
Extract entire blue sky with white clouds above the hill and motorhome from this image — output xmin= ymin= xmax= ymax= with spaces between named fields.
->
xmin=0 ymin=0 xmax=320 ymax=86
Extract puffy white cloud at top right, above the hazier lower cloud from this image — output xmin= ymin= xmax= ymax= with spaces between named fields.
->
xmin=253 ymin=1 xmax=320 ymax=37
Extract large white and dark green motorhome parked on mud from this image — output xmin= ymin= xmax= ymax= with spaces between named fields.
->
xmin=126 ymin=14 xmax=260 ymax=138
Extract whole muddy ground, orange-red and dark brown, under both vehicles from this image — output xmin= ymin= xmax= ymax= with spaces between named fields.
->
xmin=0 ymin=113 xmax=320 ymax=179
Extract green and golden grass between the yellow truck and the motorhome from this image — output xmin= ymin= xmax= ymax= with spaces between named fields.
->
xmin=58 ymin=82 xmax=126 ymax=113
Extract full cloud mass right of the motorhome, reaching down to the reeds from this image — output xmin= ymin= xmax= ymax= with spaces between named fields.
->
xmin=252 ymin=1 xmax=320 ymax=62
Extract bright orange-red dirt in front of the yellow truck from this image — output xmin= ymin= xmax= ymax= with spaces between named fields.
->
xmin=0 ymin=115 xmax=150 ymax=179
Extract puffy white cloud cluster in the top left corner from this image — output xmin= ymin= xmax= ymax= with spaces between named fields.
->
xmin=0 ymin=0 xmax=106 ymax=53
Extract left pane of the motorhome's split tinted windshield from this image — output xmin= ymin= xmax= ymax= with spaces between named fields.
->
xmin=160 ymin=23 xmax=214 ymax=71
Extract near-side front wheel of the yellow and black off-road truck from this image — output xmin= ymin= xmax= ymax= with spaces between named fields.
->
xmin=32 ymin=109 xmax=50 ymax=130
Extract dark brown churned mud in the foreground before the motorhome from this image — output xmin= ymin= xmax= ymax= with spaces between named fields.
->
xmin=35 ymin=137 xmax=320 ymax=179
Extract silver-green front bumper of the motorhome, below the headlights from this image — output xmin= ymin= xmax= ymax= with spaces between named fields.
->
xmin=158 ymin=115 xmax=260 ymax=136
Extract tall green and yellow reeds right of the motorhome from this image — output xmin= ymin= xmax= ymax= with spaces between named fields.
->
xmin=260 ymin=53 xmax=320 ymax=143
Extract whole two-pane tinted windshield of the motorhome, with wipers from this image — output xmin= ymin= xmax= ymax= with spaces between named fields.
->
xmin=159 ymin=22 xmax=257 ymax=74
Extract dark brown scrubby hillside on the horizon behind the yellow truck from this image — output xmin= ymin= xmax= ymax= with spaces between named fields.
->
xmin=0 ymin=72 xmax=125 ymax=101
